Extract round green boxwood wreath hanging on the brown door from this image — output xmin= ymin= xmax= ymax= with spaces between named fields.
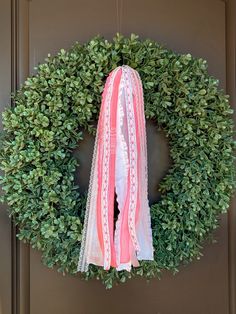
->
xmin=1 ymin=34 xmax=235 ymax=288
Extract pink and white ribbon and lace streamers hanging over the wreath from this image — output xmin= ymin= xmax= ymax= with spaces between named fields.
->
xmin=78 ymin=65 xmax=153 ymax=272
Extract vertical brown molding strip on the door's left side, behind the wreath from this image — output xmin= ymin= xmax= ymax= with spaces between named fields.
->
xmin=11 ymin=0 xmax=30 ymax=314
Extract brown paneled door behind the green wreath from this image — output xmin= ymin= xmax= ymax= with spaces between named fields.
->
xmin=0 ymin=0 xmax=236 ymax=314
